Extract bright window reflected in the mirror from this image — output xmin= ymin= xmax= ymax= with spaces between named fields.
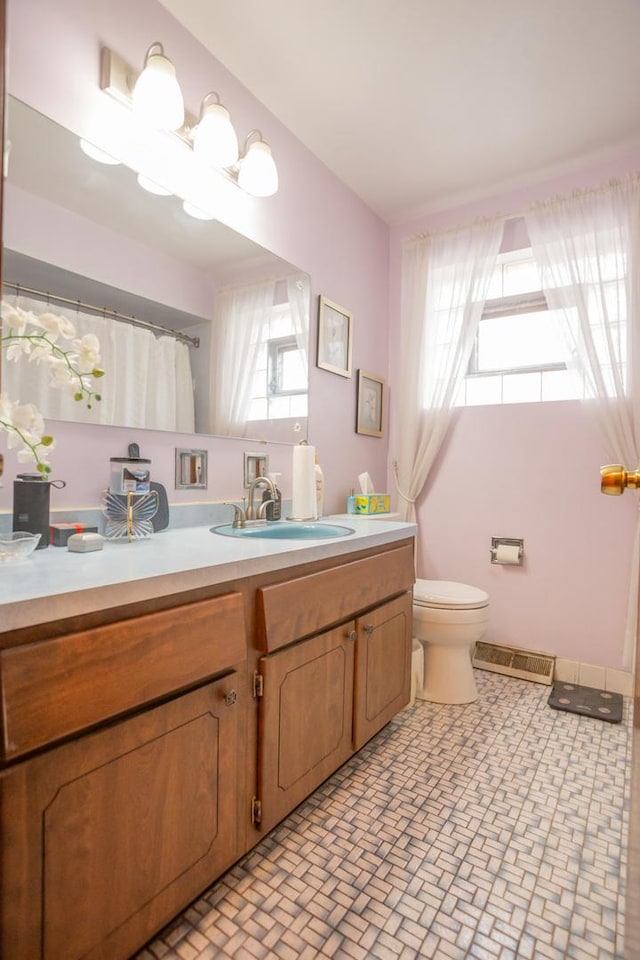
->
xmin=248 ymin=303 xmax=308 ymax=420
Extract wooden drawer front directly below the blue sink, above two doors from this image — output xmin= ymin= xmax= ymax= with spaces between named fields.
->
xmin=258 ymin=541 xmax=415 ymax=652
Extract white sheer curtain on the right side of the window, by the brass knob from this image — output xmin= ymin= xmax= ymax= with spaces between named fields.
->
xmin=525 ymin=176 xmax=640 ymax=669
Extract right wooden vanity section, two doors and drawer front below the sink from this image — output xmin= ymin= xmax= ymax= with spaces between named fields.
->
xmin=255 ymin=544 xmax=414 ymax=830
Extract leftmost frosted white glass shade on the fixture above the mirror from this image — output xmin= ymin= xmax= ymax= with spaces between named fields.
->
xmin=131 ymin=43 xmax=184 ymax=130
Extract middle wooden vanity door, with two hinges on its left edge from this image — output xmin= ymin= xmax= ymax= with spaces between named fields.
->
xmin=258 ymin=621 xmax=355 ymax=830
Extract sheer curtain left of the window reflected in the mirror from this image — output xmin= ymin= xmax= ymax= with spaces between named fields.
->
xmin=210 ymin=279 xmax=277 ymax=436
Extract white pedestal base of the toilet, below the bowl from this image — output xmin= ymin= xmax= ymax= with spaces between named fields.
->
xmin=416 ymin=641 xmax=478 ymax=704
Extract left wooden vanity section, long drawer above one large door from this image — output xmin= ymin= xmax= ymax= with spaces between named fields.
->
xmin=0 ymin=593 xmax=249 ymax=960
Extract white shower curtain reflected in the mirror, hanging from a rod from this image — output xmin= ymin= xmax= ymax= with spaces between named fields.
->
xmin=2 ymin=294 xmax=195 ymax=433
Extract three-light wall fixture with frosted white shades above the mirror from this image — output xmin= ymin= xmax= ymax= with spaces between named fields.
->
xmin=100 ymin=43 xmax=278 ymax=199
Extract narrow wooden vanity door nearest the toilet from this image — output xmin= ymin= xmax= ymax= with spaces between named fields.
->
xmin=353 ymin=593 xmax=412 ymax=750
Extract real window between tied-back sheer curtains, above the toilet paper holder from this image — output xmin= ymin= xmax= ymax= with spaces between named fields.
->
xmin=456 ymin=249 xmax=583 ymax=406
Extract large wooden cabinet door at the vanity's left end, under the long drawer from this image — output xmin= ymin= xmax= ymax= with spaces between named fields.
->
xmin=0 ymin=674 xmax=244 ymax=960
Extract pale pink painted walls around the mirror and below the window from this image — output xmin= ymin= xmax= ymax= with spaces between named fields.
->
xmin=5 ymin=0 xmax=640 ymax=668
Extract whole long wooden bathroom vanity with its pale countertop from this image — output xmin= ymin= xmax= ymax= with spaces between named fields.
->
xmin=0 ymin=520 xmax=415 ymax=960
